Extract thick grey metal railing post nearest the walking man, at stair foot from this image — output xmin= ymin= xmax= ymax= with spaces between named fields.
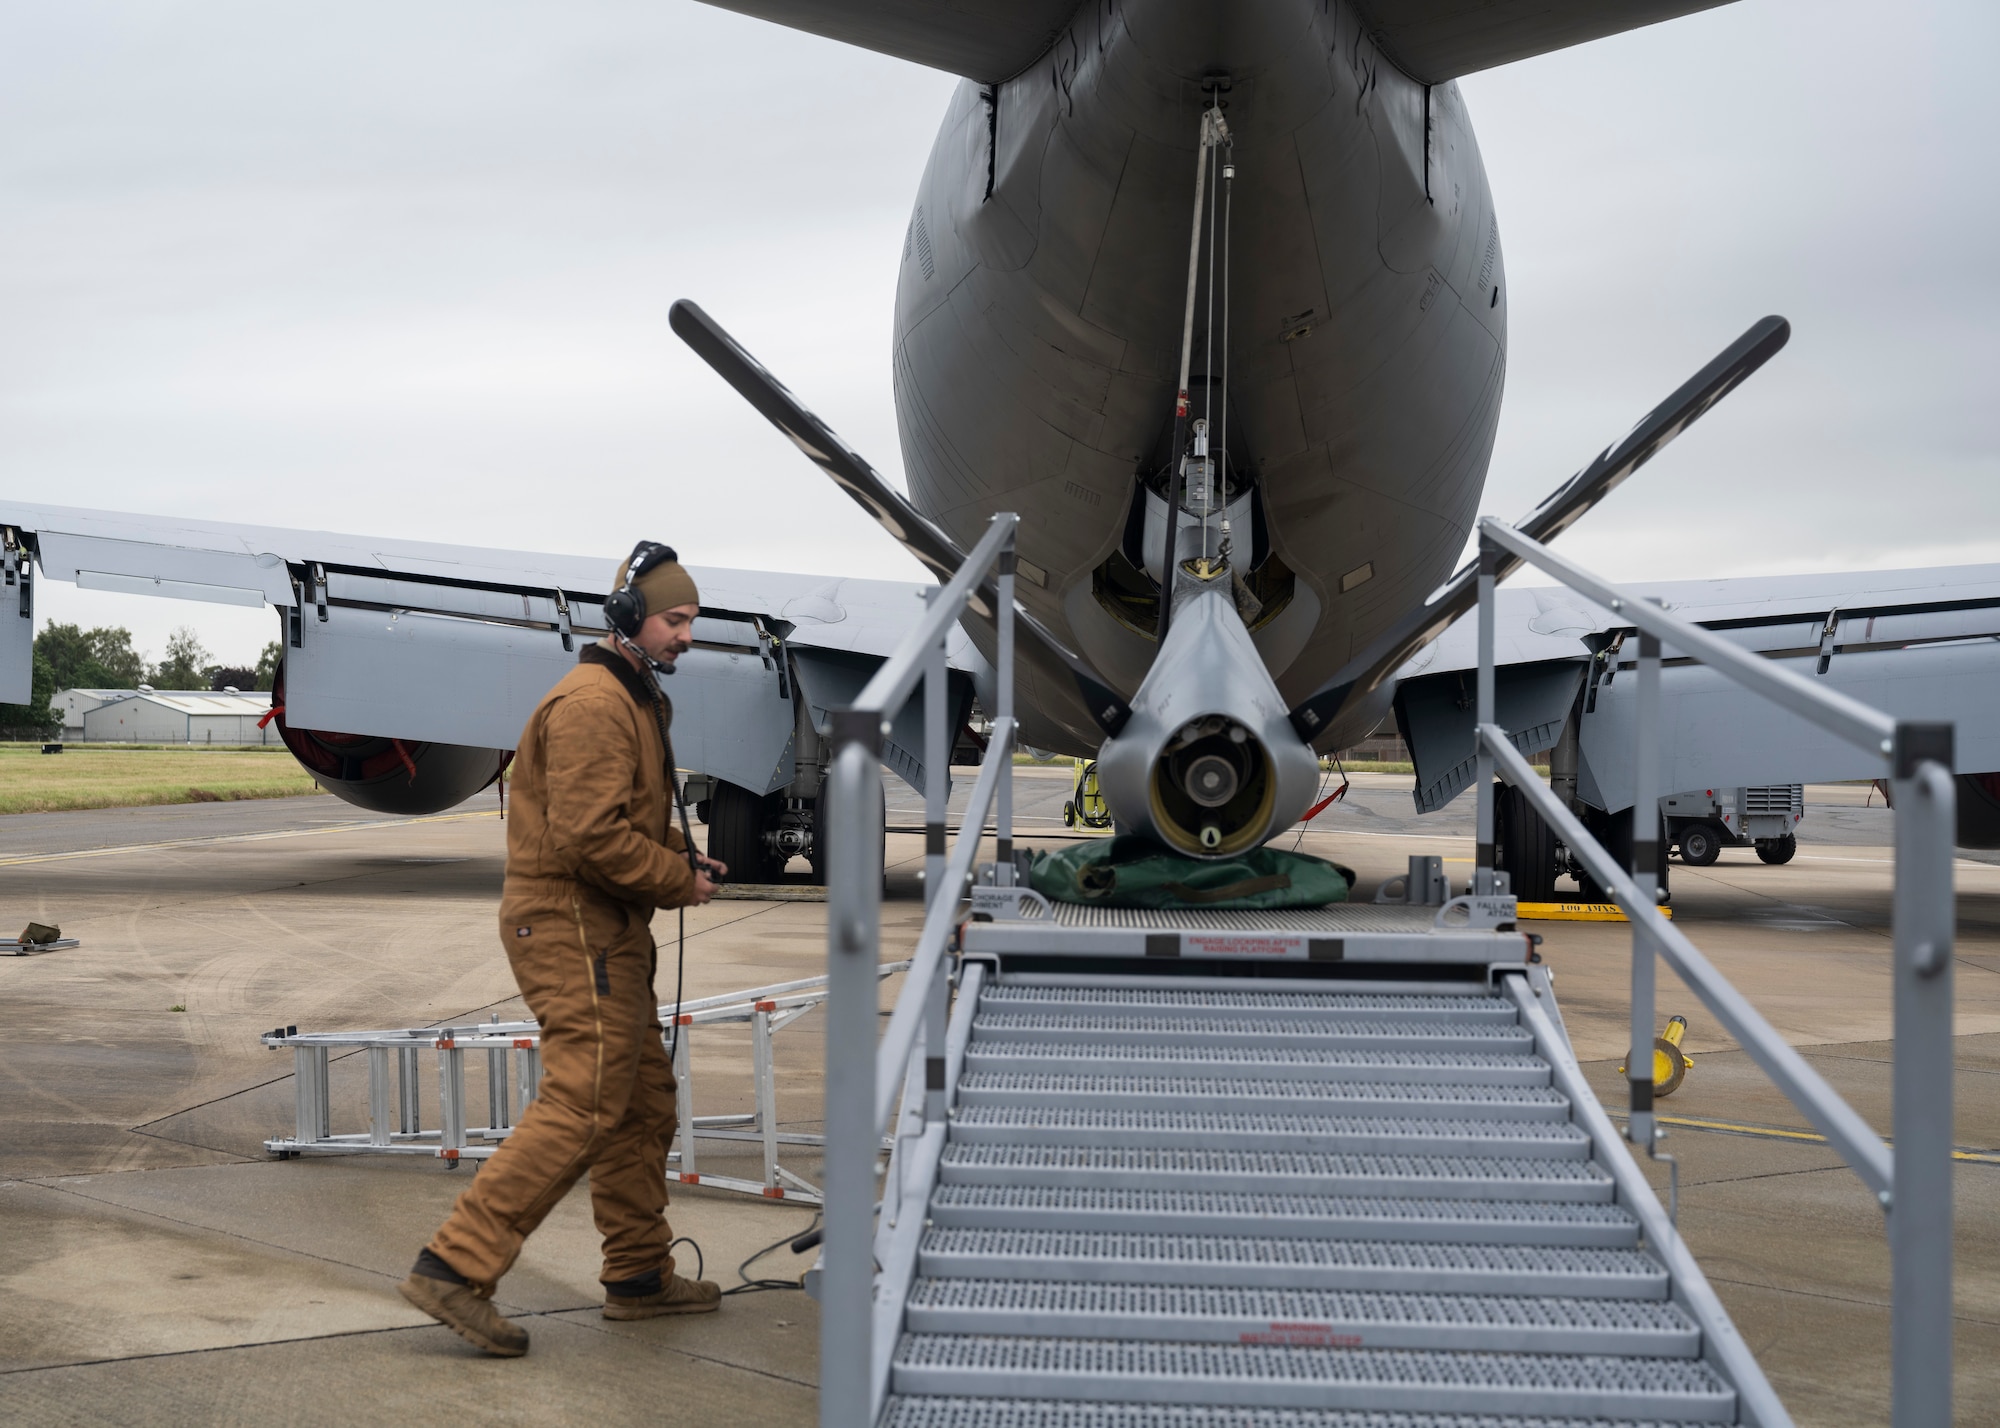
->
xmin=820 ymin=710 xmax=882 ymax=1428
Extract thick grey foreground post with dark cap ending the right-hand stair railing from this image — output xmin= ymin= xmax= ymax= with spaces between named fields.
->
xmin=1886 ymin=722 xmax=1958 ymax=1428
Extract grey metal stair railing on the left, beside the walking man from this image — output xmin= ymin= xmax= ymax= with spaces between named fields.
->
xmin=820 ymin=512 xmax=1020 ymax=1428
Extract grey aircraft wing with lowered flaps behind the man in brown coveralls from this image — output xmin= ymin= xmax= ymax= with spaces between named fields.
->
xmin=0 ymin=500 xmax=968 ymax=792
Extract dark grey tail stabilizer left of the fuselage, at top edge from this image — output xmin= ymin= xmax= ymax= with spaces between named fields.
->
xmin=704 ymin=0 xmax=1078 ymax=84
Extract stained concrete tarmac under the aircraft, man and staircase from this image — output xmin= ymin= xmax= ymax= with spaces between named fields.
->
xmin=0 ymin=768 xmax=2000 ymax=1426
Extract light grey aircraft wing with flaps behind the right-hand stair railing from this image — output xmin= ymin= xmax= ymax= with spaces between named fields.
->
xmin=1394 ymin=566 xmax=2000 ymax=812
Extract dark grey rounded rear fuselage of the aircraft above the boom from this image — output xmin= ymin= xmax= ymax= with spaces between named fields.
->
xmin=894 ymin=0 xmax=1506 ymax=752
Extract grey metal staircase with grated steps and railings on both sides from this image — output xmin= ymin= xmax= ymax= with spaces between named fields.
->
xmin=812 ymin=514 xmax=1954 ymax=1428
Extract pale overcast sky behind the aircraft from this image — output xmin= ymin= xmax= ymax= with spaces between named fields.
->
xmin=0 ymin=0 xmax=2000 ymax=662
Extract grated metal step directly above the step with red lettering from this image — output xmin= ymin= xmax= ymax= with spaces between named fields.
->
xmin=918 ymin=1228 xmax=1668 ymax=1300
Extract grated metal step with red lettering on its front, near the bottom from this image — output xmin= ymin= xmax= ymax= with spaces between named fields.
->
xmin=904 ymin=1278 xmax=1702 ymax=1358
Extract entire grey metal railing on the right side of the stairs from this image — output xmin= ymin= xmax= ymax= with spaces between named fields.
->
xmin=1472 ymin=518 xmax=1956 ymax=1428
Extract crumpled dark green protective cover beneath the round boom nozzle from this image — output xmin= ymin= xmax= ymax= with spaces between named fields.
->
xmin=1028 ymin=834 xmax=1354 ymax=908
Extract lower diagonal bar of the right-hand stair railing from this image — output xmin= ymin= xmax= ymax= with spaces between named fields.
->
xmin=1478 ymin=724 xmax=1896 ymax=1194
